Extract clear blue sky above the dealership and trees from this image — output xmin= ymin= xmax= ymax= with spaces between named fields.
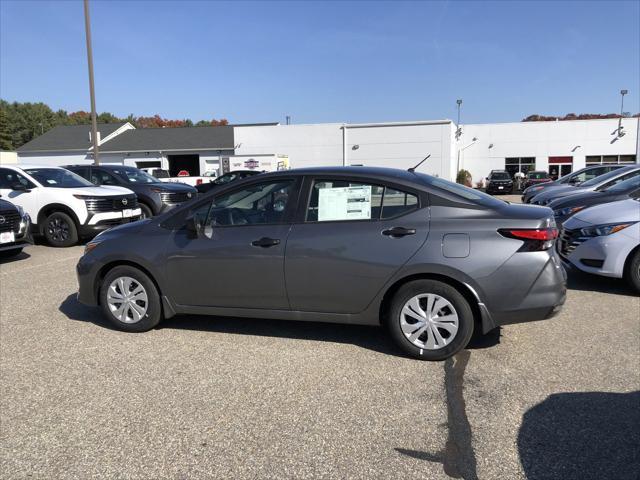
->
xmin=0 ymin=0 xmax=640 ymax=123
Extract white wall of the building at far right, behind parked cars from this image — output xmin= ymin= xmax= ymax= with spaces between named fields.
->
xmin=456 ymin=118 xmax=638 ymax=181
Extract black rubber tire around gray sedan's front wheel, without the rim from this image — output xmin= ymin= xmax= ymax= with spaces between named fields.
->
xmin=100 ymin=265 xmax=162 ymax=332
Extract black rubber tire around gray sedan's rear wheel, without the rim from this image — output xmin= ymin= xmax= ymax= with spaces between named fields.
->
xmin=385 ymin=280 xmax=475 ymax=361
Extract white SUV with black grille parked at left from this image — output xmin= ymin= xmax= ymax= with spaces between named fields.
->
xmin=0 ymin=165 xmax=142 ymax=247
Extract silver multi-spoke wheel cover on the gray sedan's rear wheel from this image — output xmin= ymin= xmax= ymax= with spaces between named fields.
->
xmin=400 ymin=293 xmax=459 ymax=350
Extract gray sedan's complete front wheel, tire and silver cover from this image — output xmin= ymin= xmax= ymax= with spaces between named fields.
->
xmin=100 ymin=266 xmax=162 ymax=332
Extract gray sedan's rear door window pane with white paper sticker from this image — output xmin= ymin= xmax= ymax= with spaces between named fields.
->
xmin=306 ymin=180 xmax=384 ymax=222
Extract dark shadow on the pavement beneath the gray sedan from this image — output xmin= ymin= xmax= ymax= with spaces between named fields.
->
xmin=59 ymin=295 xmax=500 ymax=357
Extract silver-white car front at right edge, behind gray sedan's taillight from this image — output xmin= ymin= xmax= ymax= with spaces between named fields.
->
xmin=556 ymin=199 xmax=640 ymax=292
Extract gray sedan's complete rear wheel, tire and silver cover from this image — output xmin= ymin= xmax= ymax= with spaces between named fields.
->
xmin=386 ymin=280 xmax=474 ymax=360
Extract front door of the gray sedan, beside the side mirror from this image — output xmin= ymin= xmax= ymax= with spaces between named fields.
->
xmin=166 ymin=177 xmax=300 ymax=310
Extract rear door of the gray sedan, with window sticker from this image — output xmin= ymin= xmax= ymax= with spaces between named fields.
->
xmin=285 ymin=177 xmax=429 ymax=313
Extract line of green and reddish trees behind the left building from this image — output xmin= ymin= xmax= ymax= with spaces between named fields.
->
xmin=0 ymin=99 xmax=229 ymax=151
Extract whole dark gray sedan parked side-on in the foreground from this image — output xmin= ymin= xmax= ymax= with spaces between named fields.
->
xmin=77 ymin=167 xmax=566 ymax=360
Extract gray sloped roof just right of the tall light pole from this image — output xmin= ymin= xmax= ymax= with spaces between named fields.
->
xmin=100 ymin=125 xmax=234 ymax=152
